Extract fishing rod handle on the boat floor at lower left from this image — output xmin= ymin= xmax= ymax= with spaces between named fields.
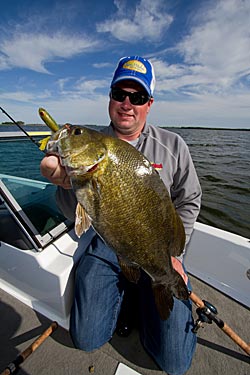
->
xmin=0 ymin=322 xmax=58 ymax=375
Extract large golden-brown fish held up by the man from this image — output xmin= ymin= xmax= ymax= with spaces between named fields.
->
xmin=48 ymin=125 xmax=188 ymax=319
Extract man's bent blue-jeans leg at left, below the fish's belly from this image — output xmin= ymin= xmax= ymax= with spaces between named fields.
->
xmin=70 ymin=256 xmax=123 ymax=352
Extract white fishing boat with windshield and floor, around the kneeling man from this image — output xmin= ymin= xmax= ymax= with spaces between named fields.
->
xmin=0 ymin=174 xmax=250 ymax=375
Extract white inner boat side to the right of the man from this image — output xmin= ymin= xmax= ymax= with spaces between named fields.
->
xmin=185 ymin=222 xmax=250 ymax=307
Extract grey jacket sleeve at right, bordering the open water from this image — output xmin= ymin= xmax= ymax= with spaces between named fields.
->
xmin=170 ymin=141 xmax=202 ymax=244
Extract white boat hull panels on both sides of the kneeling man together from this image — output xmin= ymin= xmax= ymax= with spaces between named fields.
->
xmin=0 ymin=223 xmax=250 ymax=329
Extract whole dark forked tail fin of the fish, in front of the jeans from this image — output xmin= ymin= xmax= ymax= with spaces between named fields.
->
xmin=152 ymin=270 xmax=189 ymax=320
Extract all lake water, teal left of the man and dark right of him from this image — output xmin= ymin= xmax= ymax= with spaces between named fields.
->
xmin=0 ymin=126 xmax=250 ymax=238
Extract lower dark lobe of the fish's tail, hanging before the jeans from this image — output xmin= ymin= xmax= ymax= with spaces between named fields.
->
xmin=152 ymin=282 xmax=174 ymax=320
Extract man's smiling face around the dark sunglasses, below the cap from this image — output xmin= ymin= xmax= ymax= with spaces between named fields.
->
xmin=109 ymin=80 xmax=154 ymax=135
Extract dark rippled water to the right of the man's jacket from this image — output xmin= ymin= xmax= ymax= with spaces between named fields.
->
xmin=174 ymin=129 xmax=250 ymax=238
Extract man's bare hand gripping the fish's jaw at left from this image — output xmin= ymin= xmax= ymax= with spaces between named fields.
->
xmin=40 ymin=155 xmax=71 ymax=189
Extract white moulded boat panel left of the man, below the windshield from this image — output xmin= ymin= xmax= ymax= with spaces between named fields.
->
xmin=0 ymin=230 xmax=94 ymax=328
